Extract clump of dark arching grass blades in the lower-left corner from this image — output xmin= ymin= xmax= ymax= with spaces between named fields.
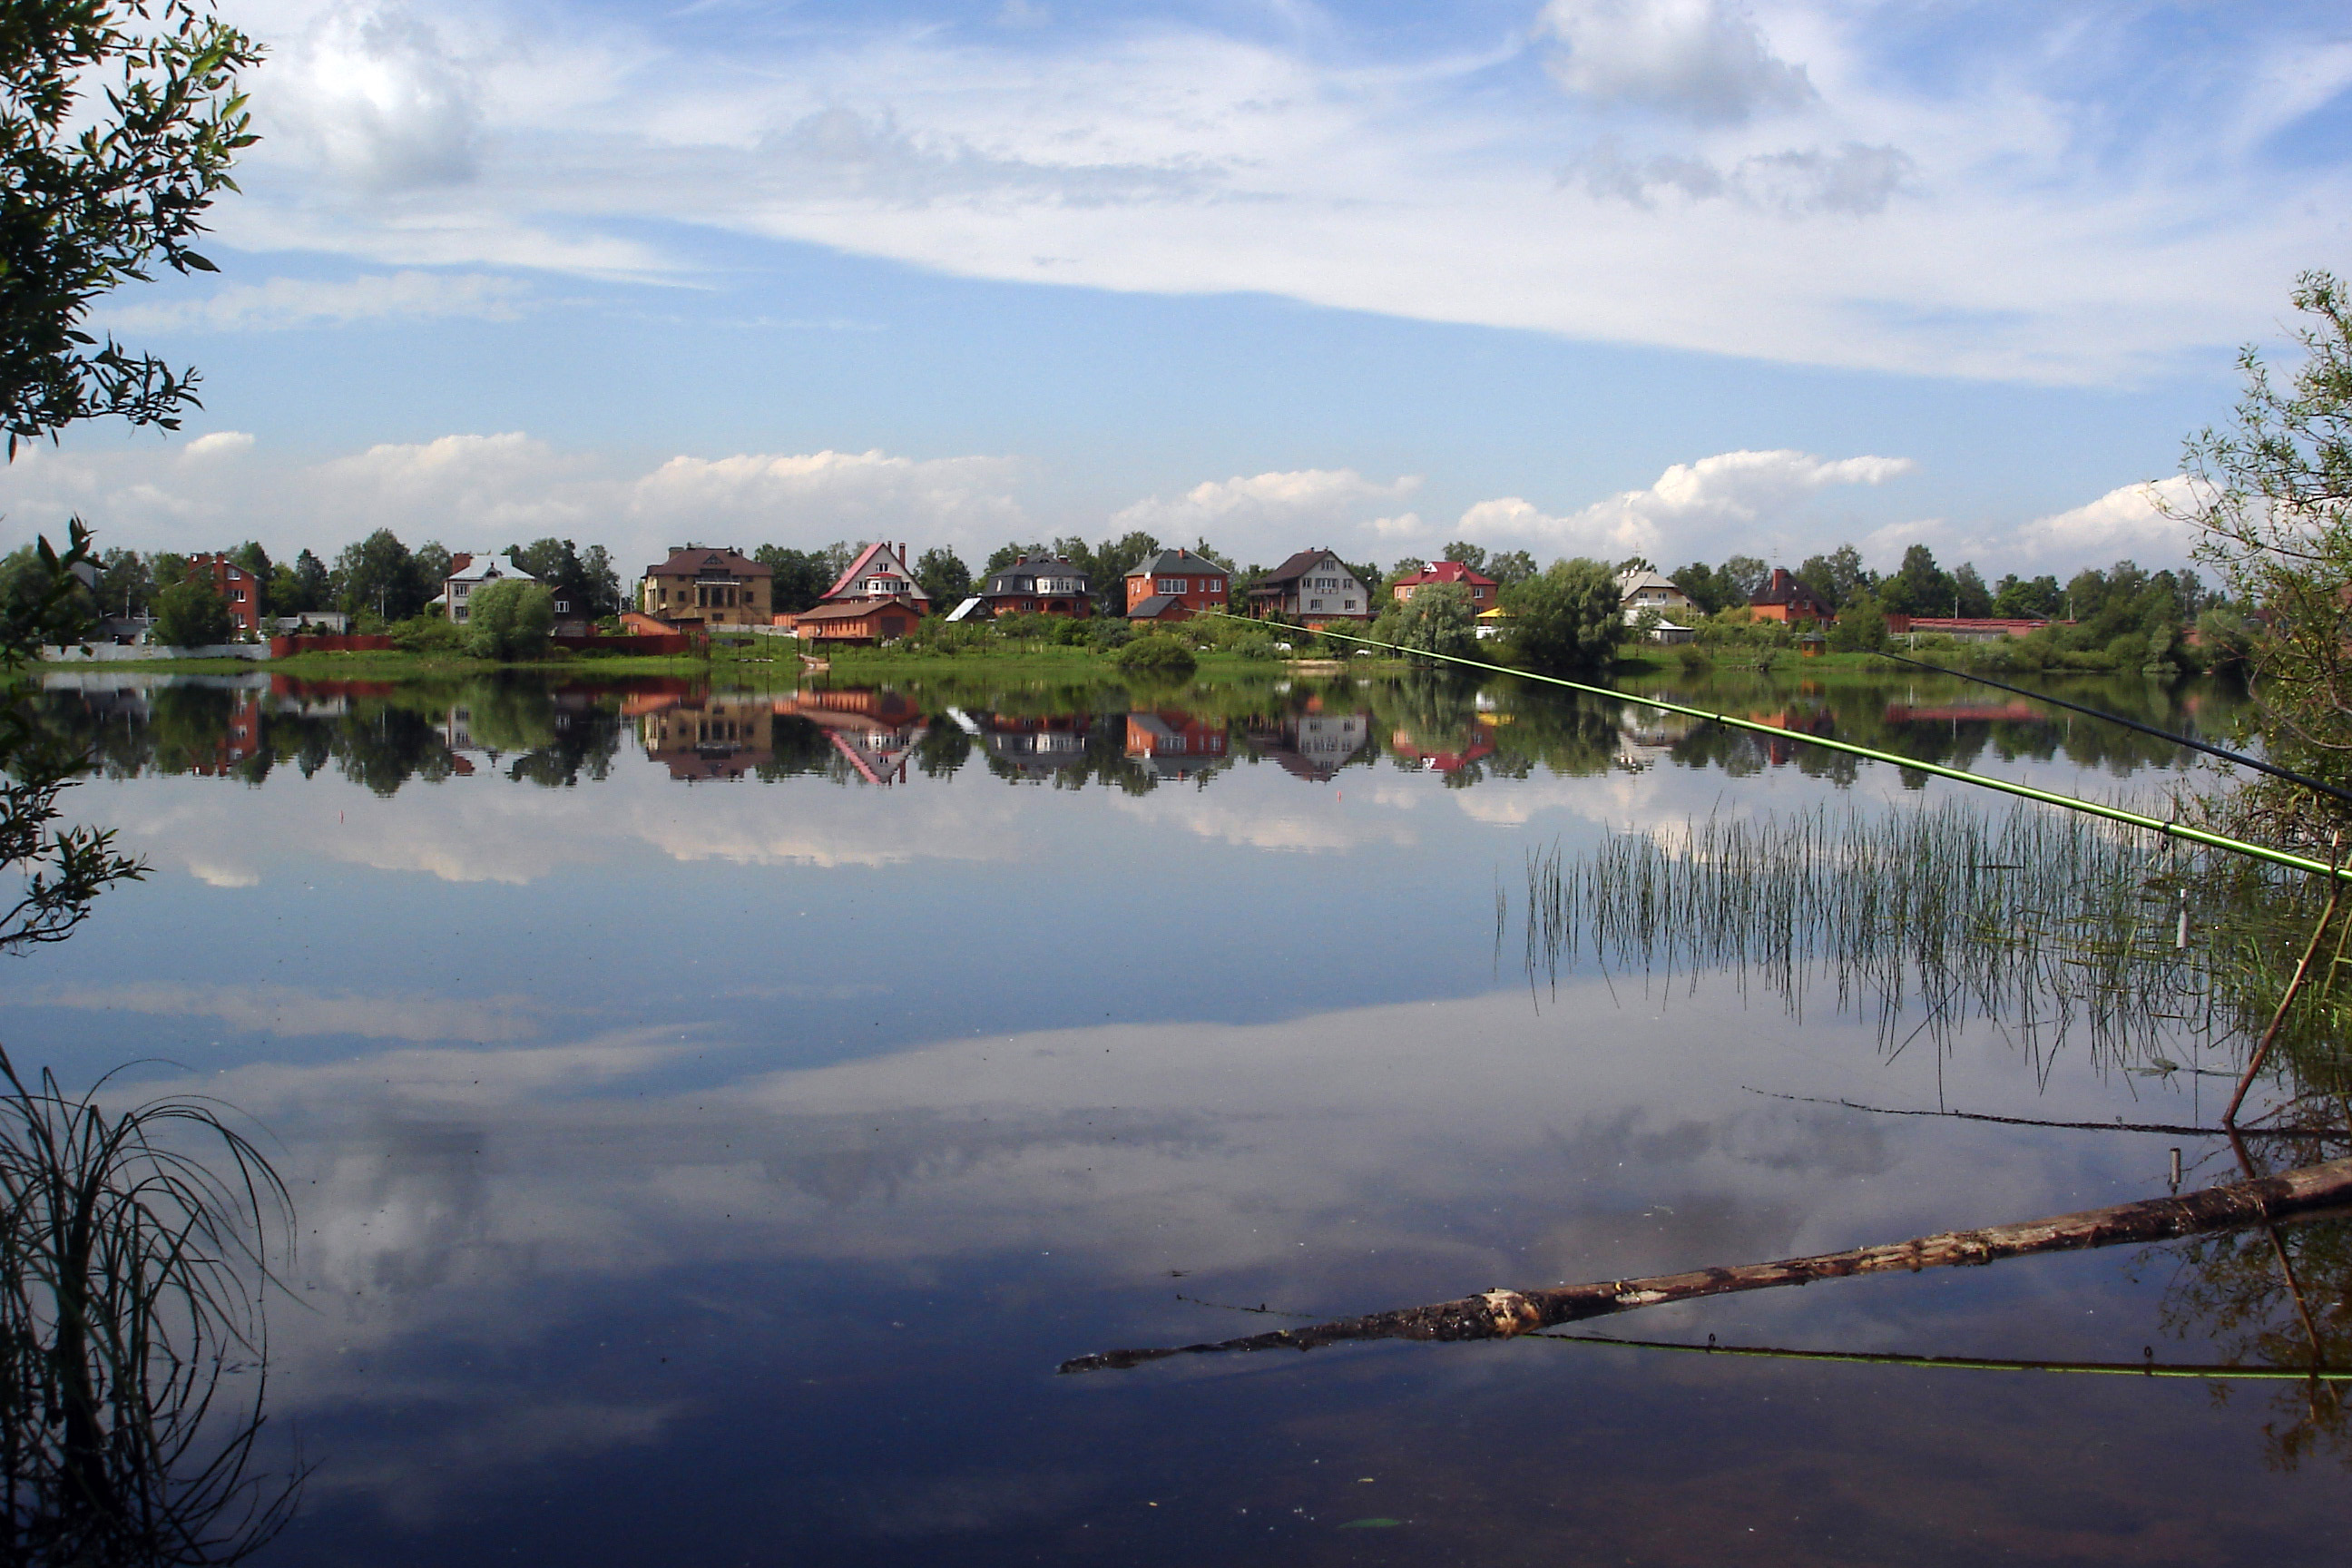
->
xmin=0 ymin=1054 xmax=301 ymax=1568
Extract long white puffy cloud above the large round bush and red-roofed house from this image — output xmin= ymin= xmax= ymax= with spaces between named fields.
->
xmin=1455 ymin=449 xmax=1915 ymax=554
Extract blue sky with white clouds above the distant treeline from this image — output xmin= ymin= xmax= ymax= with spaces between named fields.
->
xmin=0 ymin=0 xmax=2352 ymax=573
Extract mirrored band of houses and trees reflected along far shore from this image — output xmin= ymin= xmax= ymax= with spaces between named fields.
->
xmin=40 ymin=670 xmax=2237 ymax=795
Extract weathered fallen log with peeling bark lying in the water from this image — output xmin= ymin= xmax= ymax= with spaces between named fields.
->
xmin=1061 ymin=1159 xmax=2352 ymax=1373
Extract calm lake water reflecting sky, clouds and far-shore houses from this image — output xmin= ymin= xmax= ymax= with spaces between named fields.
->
xmin=14 ymin=675 xmax=2347 ymax=1565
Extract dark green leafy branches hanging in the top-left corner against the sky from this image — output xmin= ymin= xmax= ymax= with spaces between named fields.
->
xmin=0 ymin=0 xmax=261 ymax=456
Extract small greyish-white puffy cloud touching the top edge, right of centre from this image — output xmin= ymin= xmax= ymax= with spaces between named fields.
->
xmin=1536 ymin=0 xmax=1813 ymax=120
